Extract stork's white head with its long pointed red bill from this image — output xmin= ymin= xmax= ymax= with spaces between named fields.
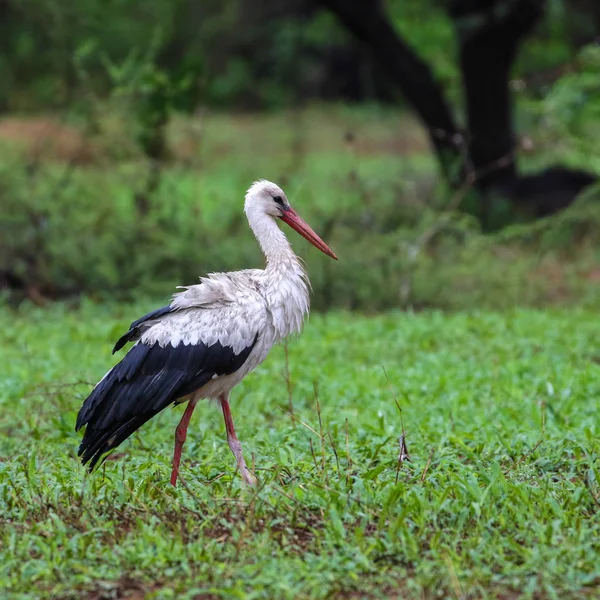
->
xmin=244 ymin=179 xmax=337 ymax=260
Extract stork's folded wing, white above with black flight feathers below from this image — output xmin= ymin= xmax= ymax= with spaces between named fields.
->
xmin=76 ymin=284 xmax=267 ymax=470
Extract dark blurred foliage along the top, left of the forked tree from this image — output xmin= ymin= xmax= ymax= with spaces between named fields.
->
xmin=0 ymin=0 xmax=338 ymax=110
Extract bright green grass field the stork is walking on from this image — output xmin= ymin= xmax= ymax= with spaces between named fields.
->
xmin=0 ymin=303 xmax=600 ymax=599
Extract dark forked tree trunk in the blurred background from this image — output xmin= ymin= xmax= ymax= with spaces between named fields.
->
xmin=318 ymin=0 xmax=595 ymax=222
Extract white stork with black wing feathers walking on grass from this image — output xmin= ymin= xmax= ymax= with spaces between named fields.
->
xmin=76 ymin=180 xmax=337 ymax=485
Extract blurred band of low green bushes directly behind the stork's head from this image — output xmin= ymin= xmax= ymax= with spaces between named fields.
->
xmin=0 ymin=146 xmax=600 ymax=311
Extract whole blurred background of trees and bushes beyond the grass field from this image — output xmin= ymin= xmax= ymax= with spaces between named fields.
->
xmin=0 ymin=0 xmax=600 ymax=311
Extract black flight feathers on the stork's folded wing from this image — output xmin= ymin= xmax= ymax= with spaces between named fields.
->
xmin=75 ymin=336 xmax=258 ymax=471
